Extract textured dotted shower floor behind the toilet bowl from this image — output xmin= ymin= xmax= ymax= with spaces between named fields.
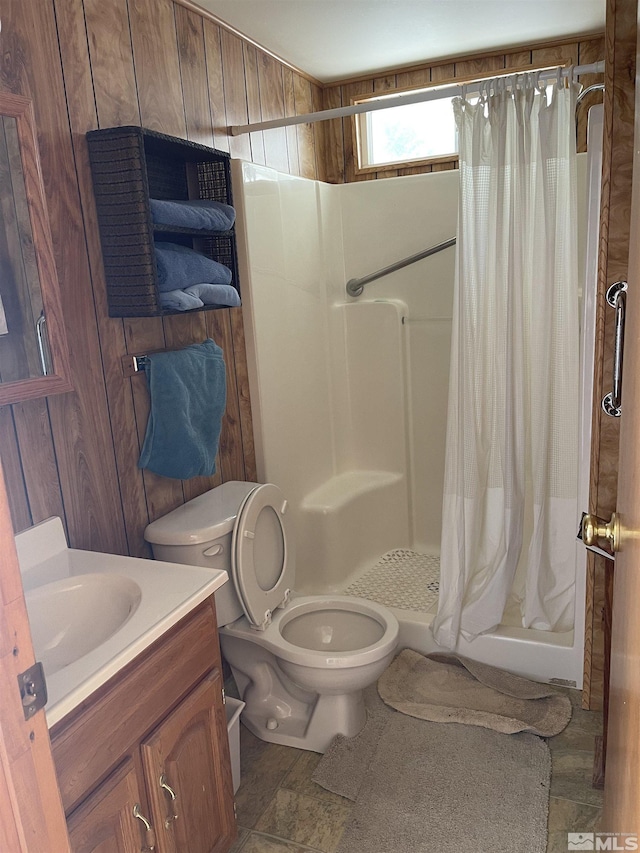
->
xmin=344 ymin=548 xmax=440 ymax=612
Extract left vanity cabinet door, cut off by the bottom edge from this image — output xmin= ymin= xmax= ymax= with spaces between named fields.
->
xmin=67 ymin=761 xmax=155 ymax=853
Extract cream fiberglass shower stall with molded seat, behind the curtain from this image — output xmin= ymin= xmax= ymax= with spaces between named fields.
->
xmin=232 ymin=103 xmax=602 ymax=686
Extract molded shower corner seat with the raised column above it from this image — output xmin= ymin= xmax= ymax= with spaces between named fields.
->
xmin=298 ymin=301 xmax=411 ymax=593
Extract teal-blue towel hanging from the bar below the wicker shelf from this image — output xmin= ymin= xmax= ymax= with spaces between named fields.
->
xmin=138 ymin=338 xmax=227 ymax=480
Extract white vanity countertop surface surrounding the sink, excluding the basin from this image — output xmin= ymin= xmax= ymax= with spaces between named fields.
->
xmin=16 ymin=518 xmax=228 ymax=728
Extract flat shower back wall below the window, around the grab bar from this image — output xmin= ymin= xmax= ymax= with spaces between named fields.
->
xmin=338 ymin=170 xmax=458 ymax=553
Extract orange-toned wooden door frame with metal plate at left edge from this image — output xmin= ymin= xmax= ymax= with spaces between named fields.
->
xmin=0 ymin=456 xmax=69 ymax=853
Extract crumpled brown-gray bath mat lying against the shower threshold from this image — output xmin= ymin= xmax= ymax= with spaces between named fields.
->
xmin=378 ymin=649 xmax=571 ymax=737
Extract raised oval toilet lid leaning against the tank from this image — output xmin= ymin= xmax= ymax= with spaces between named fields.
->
xmin=231 ymin=483 xmax=294 ymax=628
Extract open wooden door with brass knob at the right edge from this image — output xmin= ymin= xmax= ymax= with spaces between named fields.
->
xmin=602 ymin=6 xmax=640 ymax=832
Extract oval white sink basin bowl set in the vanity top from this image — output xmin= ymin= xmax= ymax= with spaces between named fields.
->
xmin=25 ymin=572 xmax=142 ymax=676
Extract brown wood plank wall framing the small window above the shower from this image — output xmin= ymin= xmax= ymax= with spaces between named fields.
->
xmin=323 ymin=36 xmax=604 ymax=184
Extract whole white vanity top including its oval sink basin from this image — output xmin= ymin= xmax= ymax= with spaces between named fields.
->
xmin=16 ymin=518 xmax=227 ymax=728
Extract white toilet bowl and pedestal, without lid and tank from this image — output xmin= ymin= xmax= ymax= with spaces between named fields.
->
xmin=219 ymin=596 xmax=398 ymax=753
